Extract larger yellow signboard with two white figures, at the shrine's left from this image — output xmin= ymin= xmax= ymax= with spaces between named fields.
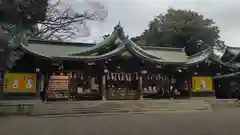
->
xmin=3 ymin=73 xmax=36 ymax=93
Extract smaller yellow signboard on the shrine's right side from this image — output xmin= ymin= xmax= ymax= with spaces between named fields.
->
xmin=192 ymin=76 xmax=213 ymax=92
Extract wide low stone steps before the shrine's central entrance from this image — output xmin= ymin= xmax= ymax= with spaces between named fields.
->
xmin=0 ymin=100 xmax=214 ymax=115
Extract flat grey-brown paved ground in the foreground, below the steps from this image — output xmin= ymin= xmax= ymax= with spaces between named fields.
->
xmin=0 ymin=109 xmax=240 ymax=135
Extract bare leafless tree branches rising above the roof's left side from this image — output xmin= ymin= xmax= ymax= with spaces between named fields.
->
xmin=32 ymin=0 xmax=108 ymax=40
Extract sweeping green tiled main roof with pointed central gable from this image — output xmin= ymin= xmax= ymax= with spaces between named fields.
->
xmin=21 ymin=25 xmax=214 ymax=64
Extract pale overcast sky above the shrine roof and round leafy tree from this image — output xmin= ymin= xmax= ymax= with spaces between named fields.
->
xmin=68 ymin=0 xmax=240 ymax=47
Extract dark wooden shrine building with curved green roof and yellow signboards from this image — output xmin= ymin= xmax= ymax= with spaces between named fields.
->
xmin=1 ymin=25 xmax=240 ymax=100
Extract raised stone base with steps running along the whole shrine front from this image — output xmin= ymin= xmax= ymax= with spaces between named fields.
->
xmin=0 ymin=99 xmax=239 ymax=116
